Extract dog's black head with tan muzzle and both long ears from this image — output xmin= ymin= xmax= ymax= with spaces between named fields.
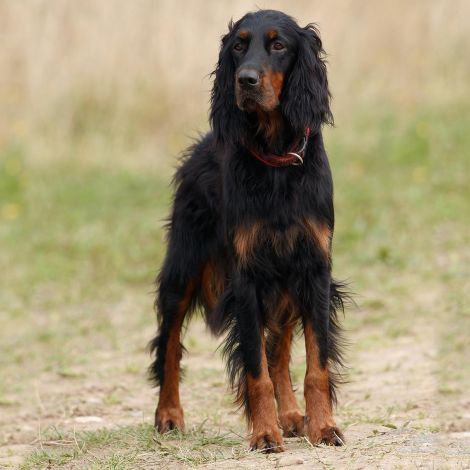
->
xmin=211 ymin=10 xmax=332 ymax=141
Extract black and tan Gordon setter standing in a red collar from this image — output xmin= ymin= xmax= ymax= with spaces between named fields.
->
xmin=150 ymin=10 xmax=344 ymax=451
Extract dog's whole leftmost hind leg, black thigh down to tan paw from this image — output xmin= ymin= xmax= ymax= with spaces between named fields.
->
xmin=149 ymin=143 xmax=217 ymax=432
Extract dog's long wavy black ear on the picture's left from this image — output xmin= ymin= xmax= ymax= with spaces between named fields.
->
xmin=210 ymin=20 xmax=245 ymax=144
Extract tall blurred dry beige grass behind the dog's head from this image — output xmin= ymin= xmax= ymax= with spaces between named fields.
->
xmin=0 ymin=0 xmax=470 ymax=169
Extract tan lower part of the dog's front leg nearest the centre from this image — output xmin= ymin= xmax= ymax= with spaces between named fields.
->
xmin=246 ymin=333 xmax=284 ymax=452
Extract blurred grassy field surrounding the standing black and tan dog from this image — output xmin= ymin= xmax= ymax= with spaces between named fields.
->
xmin=0 ymin=0 xmax=470 ymax=468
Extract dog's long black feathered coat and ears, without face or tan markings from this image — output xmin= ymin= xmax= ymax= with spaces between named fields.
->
xmin=150 ymin=10 xmax=348 ymax=430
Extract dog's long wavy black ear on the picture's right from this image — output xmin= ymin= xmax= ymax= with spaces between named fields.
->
xmin=281 ymin=24 xmax=333 ymax=133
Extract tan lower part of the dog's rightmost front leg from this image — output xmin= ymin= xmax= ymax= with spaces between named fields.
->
xmin=304 ymin=320 xmax=344 ymax=445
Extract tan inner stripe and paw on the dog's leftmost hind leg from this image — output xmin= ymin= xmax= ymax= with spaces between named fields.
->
xmin=155 ymin=282 xmax=195 ymax=432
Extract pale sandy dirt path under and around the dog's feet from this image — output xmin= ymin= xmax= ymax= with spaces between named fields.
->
xmin=0 ymin=306 xmax=470 ymax=469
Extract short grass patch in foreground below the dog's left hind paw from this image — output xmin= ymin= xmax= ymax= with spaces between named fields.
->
xmin=21 ymin=423 xmax=242 ymax=470
